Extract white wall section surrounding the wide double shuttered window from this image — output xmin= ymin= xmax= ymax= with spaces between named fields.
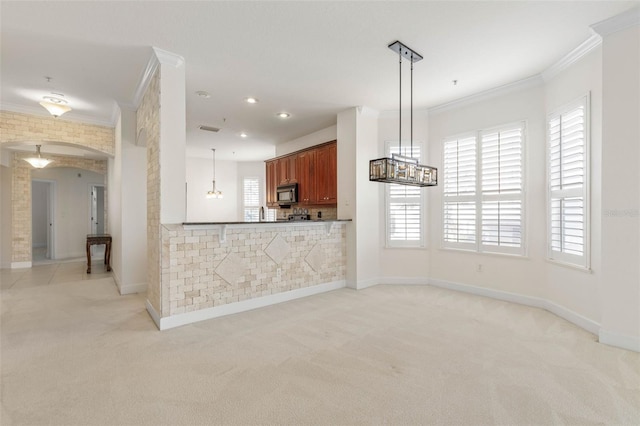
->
xmin=427 ymin=81 xmax=546 ymax=297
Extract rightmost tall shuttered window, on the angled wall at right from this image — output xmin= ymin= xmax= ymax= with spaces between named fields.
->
xmin=547 ymin=95 xmax=589 ymax=268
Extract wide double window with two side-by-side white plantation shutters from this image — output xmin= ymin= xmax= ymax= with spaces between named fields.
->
xmin=442 ymin=123 xmax=525 ymax=254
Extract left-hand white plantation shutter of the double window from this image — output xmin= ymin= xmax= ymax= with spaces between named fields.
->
xmin=443 ymin=135 xmax=477 ymax=248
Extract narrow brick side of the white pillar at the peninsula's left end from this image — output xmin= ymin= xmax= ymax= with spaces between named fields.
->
xmin=136 ymin=68 xmax=164 ymax=312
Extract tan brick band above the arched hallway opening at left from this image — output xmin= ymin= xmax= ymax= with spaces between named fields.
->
xmin=0 ymin=111 xmax=115 ymax=155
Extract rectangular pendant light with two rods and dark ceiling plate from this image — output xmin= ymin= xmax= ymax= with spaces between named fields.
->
xmin=369 ymin=41 xmax=438 ymax=186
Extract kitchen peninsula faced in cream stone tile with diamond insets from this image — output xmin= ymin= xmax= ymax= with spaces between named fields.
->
xmin=147 ymin=220 xmax=350 ymax=329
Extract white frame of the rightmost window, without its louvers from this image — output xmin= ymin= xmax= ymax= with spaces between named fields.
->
xmin=546 ymin=92 xmax=591 ymax=271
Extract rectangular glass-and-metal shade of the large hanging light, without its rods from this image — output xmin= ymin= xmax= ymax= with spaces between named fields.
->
xmin=369 ymin=155 xmax=438 ymax=186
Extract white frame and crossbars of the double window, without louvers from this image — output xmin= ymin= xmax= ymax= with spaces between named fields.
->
xmin=441 ymin=120 xmax=527 ymax=256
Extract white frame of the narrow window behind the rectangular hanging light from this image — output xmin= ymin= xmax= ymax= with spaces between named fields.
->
xmin=384 ymin=141 xmax=426 ymax=248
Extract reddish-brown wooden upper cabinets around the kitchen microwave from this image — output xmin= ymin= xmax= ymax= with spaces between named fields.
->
xmin=266 ymin=141 xmax=338 ymax=207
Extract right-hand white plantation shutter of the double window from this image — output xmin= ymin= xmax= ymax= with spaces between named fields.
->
xmin=481 ymin=124 xmax=524 ymax=253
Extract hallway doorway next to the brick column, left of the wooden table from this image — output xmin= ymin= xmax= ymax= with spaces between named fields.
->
xmin=31 ymin=179 xmax=56 ymax=262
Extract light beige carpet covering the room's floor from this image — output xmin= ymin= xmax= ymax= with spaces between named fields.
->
xmin=0 ymin=278 xmax=640 ymax=425
